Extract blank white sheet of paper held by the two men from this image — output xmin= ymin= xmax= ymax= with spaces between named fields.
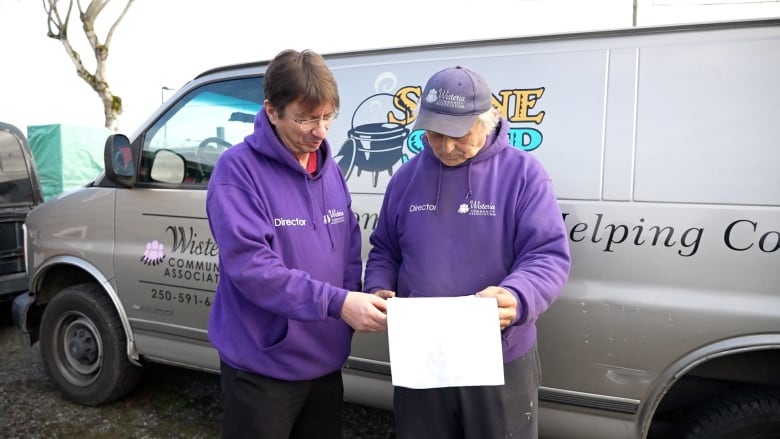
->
xmin=387 ymin=296 xmax=504 ymax=389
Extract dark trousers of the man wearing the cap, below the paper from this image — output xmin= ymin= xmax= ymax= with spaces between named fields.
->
xmin=393 ymin=346 xmax=542 ymax=439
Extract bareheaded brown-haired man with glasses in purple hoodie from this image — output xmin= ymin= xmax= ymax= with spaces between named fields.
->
xmin=206 ymin=50 xmax=386 ymax=439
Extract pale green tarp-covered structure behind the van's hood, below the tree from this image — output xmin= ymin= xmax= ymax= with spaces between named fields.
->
xmin=27 ymin=124 xmax=109 ymax=200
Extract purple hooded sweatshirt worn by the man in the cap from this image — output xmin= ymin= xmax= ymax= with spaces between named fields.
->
xmin=365 ymin=120 xmax=570 ymax=363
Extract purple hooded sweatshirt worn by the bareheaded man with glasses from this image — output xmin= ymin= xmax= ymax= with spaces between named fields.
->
xmin=206 ymin=110 xmax=362 ymax=381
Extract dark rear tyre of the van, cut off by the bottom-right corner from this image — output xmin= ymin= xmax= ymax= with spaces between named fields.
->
xmin=683 ymin=388 xmax=780 ymax=439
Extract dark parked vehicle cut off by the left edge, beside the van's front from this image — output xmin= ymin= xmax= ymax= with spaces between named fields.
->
xmin=0 ymin=122 xmax=43 ymax=304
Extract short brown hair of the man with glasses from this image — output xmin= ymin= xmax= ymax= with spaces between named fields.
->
xmin=263 ymin=49 xmax=340 ymax=116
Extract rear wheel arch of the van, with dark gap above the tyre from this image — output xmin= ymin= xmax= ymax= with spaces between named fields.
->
xmin=639 ymin=333 xmax=780 ymax=437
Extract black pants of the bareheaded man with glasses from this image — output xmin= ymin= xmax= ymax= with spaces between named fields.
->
xmin=221 ymin=362 xmax=344 ymax=439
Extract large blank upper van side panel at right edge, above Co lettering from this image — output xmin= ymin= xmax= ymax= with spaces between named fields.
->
xmin=634 ymin=35 xmax=780 ymax=206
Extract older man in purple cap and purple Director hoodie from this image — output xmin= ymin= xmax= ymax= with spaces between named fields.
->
xmin=365 ymin=67 xmax=570 ymax=439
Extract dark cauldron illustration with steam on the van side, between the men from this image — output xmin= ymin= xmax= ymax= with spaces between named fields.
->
xmin=336 ymin=93 xmax=409 ymax=187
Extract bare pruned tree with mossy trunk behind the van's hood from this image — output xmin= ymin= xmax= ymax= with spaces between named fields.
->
xmin=42 ymin=0 xmax=134 ymax=132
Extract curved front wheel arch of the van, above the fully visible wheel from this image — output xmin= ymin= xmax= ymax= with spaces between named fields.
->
xmin=27 ymin=256 xmax=141 ymax=366
